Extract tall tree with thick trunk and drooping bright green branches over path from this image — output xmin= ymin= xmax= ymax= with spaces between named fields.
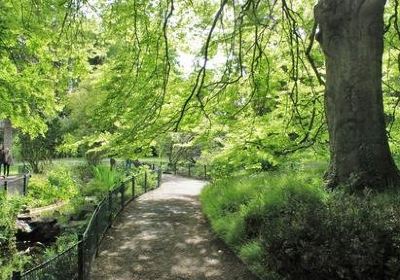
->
xmin=67 ymin=0 xmax=400 ymax=190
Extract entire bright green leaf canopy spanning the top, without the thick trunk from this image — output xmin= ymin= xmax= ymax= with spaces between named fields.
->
xmin=0 ymin=0 xmax=400 ymax=188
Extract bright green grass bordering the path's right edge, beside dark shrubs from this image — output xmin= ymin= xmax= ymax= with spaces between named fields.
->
xmin=201 ymin=172 xmax=323 ymax=279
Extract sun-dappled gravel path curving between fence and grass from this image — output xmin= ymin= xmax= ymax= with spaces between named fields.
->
xmin=91 ymin=175 xmax=257 ymax=280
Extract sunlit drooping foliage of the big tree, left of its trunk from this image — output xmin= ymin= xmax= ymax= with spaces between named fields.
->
xmin=63 ymin=1 xmax=324 ymax=162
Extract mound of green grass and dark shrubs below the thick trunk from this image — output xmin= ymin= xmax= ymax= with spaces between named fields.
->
xmin=202 ymin=174 xmax=400 ymax=279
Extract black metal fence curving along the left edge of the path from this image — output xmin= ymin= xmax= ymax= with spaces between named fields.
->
xmin=12 ymin=168 xmax=162 ymax=280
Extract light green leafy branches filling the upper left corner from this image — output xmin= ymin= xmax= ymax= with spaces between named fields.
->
xmin=0 ymin=0 xmax=90 ymax=136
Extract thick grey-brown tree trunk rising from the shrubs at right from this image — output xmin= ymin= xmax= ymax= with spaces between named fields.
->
xmin=315 ymin=0 xmax=400 ymax=189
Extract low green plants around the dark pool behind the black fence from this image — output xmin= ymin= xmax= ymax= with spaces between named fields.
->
xmin=0 ymin=161 xmax=157 ymax=280
